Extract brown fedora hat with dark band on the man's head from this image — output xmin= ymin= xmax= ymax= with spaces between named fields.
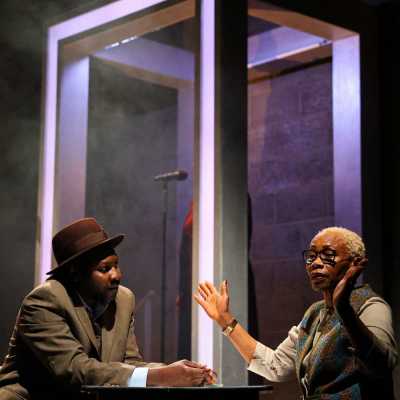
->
xmin=47 ymin=218 xmax=125 ymax=275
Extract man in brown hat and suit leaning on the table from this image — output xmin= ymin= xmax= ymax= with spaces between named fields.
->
xmin=0 ymin=218 xmax=212 ymax=400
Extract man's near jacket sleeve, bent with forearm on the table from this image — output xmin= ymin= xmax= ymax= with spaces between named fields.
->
xmin=17 ymin=284 xmax=135 ymax=387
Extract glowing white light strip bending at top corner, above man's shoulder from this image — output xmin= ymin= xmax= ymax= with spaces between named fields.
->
xmin=39 ymin=0 xmax=165 ymax=284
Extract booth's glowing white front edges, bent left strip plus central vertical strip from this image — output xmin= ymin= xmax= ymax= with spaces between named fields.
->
xmin=35 ymin=0 xmax=215 ymax=367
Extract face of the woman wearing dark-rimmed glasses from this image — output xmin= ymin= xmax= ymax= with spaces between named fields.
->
xmin=306 ymin=232 xmax=352 ymax=291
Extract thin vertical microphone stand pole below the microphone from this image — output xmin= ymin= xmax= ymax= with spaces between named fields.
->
xmin=160 ymin=180 xmax=168 ymax=362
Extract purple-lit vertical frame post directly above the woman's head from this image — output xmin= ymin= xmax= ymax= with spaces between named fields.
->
xmin=332 ymin=35 xmax=362 ymax=234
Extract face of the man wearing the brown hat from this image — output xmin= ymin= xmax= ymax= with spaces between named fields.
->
xmin=79 ymin=250 xmax=122 ymax=305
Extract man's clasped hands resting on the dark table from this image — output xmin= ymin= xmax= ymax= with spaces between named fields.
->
xmin=147 ymin=360 xmax=216 ymax=387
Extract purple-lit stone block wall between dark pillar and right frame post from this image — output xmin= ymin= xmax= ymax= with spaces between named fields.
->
xmin=248 ymin=63 xmax=334 ymax=399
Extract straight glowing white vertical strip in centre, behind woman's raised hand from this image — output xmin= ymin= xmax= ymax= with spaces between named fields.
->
xmin=197 ymin=0 xmax=215 ymax=368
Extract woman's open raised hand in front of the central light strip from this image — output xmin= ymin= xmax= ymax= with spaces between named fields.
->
xmin=194 ymin=280 xmax=232 ymax=328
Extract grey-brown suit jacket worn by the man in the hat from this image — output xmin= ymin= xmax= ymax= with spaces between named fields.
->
xmin=0 ymin=279 xmax=160 ymax=400
